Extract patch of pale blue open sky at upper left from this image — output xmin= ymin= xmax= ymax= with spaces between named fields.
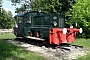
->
xmin=2 ymin=0 xmax=16 ymax=16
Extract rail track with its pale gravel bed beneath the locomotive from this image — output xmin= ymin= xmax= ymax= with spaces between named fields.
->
xmin=7 ymin=38 xmax=85 ymax=60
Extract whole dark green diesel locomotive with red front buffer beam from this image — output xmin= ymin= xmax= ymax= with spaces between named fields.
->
xmin=14 ymin=11 xmax=82 ymax=45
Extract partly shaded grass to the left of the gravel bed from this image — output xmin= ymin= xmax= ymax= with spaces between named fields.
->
xmin=0 ymin=33 xmax=47 ymax=60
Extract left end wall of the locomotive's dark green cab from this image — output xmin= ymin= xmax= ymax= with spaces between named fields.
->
xmin=14 ymin=14 xmax=23 ymax=37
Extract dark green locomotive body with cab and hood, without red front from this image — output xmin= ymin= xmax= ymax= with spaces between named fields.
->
xmin=14 ymin=11 xmax=65 ymax=38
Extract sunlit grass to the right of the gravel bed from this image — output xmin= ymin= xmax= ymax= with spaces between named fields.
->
xmin=74 ymin=38 xmax=90 ymax=60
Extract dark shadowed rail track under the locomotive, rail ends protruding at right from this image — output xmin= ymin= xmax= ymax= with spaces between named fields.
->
xmin=15 ymin=38 xmax=84 ymax=52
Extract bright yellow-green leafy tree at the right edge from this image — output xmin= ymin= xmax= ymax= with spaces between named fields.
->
xmin=70 ymin=0 xmax=90 ymax=38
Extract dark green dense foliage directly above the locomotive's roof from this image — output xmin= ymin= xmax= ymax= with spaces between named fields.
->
xmin=31 ymin=0 xmax=72 ymax=13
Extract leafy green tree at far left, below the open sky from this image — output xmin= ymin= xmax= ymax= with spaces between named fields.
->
xmin=0 ymin=8 xmax=13 ymax=29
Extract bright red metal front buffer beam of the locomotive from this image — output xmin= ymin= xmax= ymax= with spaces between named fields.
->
xmin=50 ymin=28 xmax=79 ymax=45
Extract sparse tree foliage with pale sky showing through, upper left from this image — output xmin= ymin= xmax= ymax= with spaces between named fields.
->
xmin=9 ymin=0 xmax=31 ymax=13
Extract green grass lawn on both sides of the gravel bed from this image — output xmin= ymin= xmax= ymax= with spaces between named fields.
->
xmin=0 ymin=33 xmax=90 ymax=60
